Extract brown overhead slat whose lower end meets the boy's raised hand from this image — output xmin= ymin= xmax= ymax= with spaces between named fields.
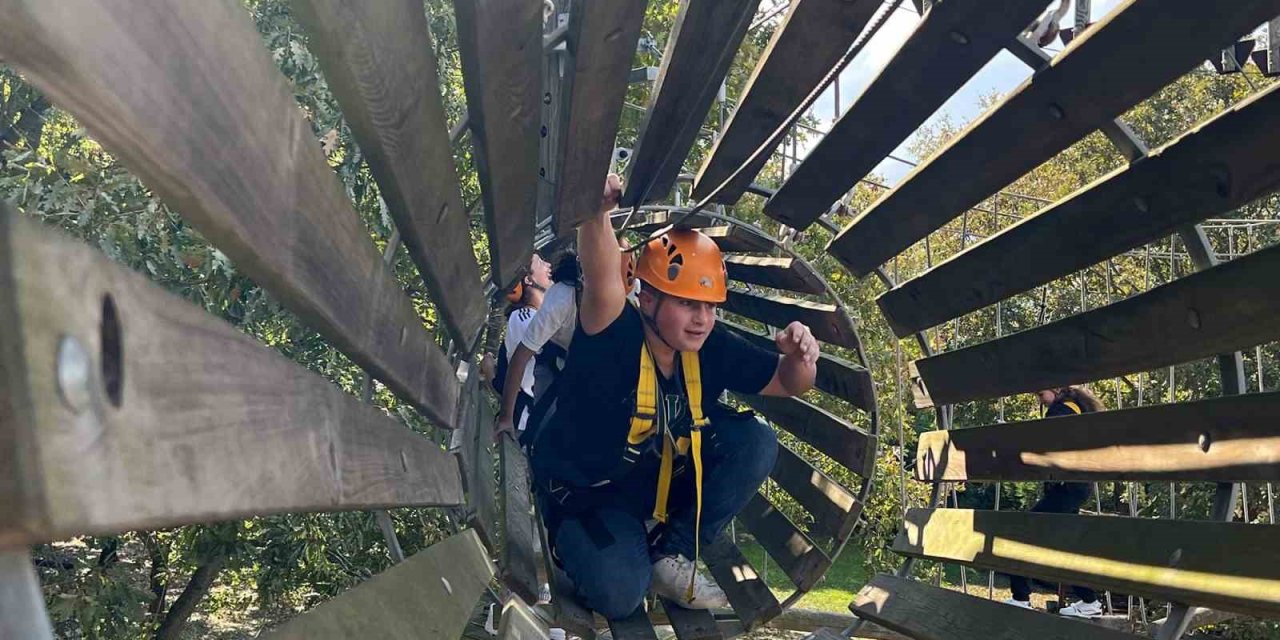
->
xmin=553 ymin=0 xmax=649 ymax=236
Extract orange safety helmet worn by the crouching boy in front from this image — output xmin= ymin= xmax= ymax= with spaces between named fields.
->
xmin=636 ymin=229 xmax=728 ymax=305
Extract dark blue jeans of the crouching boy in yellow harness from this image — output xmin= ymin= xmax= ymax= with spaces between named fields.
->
xmin=540 ymin=415 xmax=778 ymax=618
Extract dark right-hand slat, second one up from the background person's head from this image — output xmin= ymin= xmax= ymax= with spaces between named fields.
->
xmin=878 ymin=81 xmax=1280 ymax=337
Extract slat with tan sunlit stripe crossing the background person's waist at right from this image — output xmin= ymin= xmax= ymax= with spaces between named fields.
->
xmin=915 ymin=393 xmax=1280 ymax=483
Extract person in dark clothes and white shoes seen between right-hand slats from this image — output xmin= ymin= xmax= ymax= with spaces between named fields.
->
xmin=1005 ymin=387 xmax=1106 ymax=618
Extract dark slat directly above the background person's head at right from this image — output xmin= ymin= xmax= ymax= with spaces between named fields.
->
xmin=916 ymin=241 xmax=1280 ymax=403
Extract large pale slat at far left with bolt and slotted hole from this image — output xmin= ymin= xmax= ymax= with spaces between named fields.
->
xmin=0 ymin=213 xmax=462 ymax=547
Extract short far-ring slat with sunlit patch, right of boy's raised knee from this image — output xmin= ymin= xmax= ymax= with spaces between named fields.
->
xmin=771 ymin=445 xmax=863 ymax=540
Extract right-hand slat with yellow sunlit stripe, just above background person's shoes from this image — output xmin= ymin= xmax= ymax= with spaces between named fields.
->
xmin=893 ymin=509 xmax=1280 ymax=617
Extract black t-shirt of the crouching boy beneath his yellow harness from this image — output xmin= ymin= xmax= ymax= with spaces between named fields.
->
xmin=534 ymin=303 xmax=778 ymax=486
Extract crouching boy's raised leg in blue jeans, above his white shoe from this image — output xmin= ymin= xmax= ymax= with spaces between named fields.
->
xmin=655 ymin=415 xmax=778 ymax=558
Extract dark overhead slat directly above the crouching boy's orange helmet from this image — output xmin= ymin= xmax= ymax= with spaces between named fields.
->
xmin=622 ymin=0 xmax=760 ymax=206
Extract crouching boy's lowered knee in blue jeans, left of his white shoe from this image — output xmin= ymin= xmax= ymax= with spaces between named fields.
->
xmin=556 ymin=508 xmax=653 ymax=620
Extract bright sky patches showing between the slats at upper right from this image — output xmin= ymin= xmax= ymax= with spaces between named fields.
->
xmin=800 ymin=0 xmax=1123 ymax=184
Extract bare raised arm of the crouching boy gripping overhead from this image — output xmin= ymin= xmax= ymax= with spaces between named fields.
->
xmin=577 ymin=173 xmax=627 ymax=335
